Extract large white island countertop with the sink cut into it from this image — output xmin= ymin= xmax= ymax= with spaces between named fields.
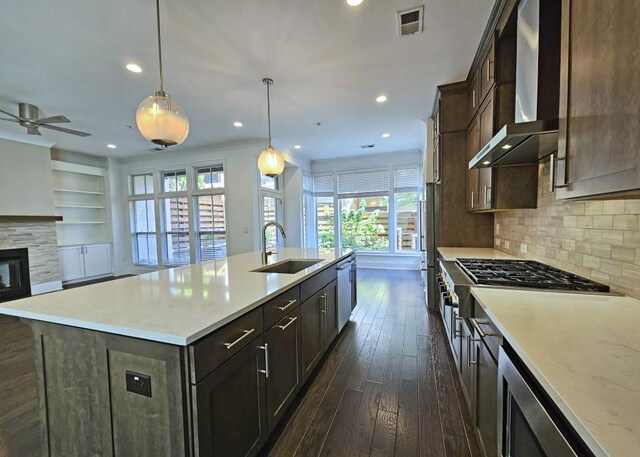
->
xmin=0 ymin=248 xmax=350 ymax=346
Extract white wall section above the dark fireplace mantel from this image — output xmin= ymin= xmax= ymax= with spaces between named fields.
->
xmin=0 ymin=139 xmax=55 ymax=216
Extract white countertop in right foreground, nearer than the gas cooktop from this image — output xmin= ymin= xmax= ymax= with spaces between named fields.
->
xmin=471 ymin=287 xmax=640 ymax=457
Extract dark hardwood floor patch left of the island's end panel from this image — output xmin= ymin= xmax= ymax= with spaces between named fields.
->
xmin=0 ymin=315 xmax=40 ymax=457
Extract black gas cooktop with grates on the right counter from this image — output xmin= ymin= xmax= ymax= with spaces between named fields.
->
xmin=457 ymin=259 xmax=609 ymax=292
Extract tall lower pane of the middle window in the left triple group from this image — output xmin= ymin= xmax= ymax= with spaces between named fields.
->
xmin=162 ymin=197 xmax=191 ymax=265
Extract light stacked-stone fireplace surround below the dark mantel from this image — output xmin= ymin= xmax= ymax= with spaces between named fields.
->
xmin=0 ymin=216 xmax=62 ymax=295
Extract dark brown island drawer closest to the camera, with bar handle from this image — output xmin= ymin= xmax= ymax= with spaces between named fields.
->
xmin=189 ymin=306 xmax=263 ymax=384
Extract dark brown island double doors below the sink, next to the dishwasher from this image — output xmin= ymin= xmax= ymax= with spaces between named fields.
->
xmin=301 ymin=280 xmax=338 ymax=380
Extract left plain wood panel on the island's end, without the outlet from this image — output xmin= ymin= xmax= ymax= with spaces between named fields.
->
xmin=32 ymin=321 xmax=113 ymax=457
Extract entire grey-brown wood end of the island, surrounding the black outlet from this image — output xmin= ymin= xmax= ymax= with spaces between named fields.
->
xmin=32 ymin=321 xmax=191 ymax=457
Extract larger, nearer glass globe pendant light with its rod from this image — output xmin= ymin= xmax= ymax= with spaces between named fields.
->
xmin=136 ymin=0 xmax=189 ymax=148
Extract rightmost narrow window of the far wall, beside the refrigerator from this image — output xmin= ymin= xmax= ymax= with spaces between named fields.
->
xmin=394 ymin=167 xmax=420 ymax=252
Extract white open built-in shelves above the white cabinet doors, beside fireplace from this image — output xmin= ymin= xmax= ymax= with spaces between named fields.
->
xmin=51 ymin=160 xmax=112 ymax=246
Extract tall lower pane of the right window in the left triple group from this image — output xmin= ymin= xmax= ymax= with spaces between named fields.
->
xmin=194 ymin=195 xmax=227 ymax=262
